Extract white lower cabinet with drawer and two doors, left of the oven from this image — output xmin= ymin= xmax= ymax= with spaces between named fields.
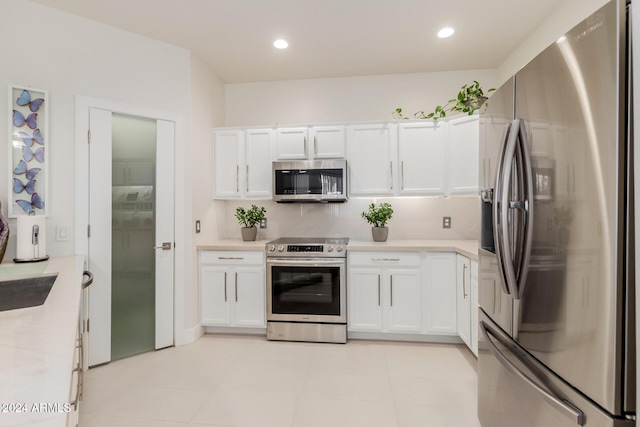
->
xmin=200 ymin=251 xmax=266 ymax=328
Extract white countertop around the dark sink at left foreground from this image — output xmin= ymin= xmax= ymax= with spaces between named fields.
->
xmin=0 ymin=256 xmax=84 ymax=427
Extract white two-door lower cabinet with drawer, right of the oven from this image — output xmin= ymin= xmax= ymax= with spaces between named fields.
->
xmin=347 ymin=252 xmax=423 ymax=333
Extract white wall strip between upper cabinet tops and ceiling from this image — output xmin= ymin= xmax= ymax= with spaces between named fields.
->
xmin=225 ymin=70 xmax=497 ymax=126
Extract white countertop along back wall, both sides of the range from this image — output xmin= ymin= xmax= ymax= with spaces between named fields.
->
xmin=197 ymin=239 xmax=478 ymax=260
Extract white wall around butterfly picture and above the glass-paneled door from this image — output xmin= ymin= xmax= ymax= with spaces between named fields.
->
xmin=0 ymin=0 xmax=190 ymax=261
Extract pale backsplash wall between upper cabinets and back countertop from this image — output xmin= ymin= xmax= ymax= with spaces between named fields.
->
xmin=218 ymin=196 xmax=480 ymax=240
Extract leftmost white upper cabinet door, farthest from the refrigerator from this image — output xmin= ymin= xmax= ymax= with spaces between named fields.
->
xmin=213 ymin=130 xmax=244 ymax=199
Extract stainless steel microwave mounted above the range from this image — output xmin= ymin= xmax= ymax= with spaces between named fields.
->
xmin=273 ymin=160 xmax=347 ymax=203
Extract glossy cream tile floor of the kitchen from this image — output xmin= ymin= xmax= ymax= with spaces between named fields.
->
xmin=80 ymin=335 xmax=480 ymax=427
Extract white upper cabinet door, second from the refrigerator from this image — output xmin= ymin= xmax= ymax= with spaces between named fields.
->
xmin=398 ymin=120 xmax=447 ymax=195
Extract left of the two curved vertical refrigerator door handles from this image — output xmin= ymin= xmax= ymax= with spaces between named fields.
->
xmin=494 ymin=119 xmax=520 ymax=298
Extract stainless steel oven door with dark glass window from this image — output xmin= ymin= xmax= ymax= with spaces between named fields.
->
xmin=267 ymin=259 xmax=346 ymax=322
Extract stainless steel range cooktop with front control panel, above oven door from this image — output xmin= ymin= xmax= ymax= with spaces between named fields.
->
xmin=266 ymin=237 xmax=349 ymax=258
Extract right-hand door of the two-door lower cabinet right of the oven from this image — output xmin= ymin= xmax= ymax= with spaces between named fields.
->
xmin=385 ymin=269 xmax=422 ymax=332
